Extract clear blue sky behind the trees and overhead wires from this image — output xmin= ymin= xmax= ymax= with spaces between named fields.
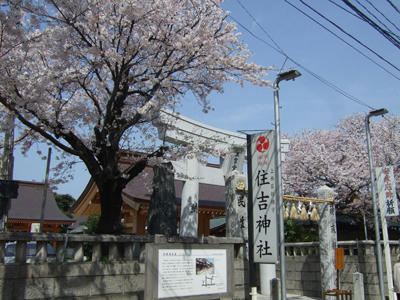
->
xmin=14 ymin=0 xmax=400 ymax=198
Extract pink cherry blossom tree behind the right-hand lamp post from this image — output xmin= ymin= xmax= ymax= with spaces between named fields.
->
xmin=283 ymin=114 xmax=400 ymax=224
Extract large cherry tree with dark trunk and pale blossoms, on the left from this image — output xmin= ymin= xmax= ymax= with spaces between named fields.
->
xmin=0 ymin=0 xmax=269 ymax=233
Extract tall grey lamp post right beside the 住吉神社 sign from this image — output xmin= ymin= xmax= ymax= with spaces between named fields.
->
xmin=273 ymin=70 xmax=301 ymax=300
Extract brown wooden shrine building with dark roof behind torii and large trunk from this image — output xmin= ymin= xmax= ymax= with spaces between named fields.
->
xmin=71 ymin=156 xmax=225 ymax=236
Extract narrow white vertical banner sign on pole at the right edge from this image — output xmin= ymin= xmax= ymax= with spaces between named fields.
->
xmin=375 ymin=166 xmax=399 ymax=217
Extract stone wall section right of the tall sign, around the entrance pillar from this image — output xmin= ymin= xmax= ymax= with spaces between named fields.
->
xmin=286 ymin=241 xmax=400 ymax=300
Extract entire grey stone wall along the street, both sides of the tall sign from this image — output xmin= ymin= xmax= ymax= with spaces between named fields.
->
xmin=0 ymin=233 xmax=400 ymax=300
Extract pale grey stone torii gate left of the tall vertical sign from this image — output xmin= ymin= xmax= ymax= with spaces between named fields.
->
xmin=155 ymin=110 xmax=247 ymax=237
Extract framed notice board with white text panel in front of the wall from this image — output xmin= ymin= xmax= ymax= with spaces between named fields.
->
xmin=144 ymin=243 xmax=234 ymax=300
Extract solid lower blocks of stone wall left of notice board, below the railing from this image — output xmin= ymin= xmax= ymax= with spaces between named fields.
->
xmin=0 ymin=261 xmax=145 ymax=300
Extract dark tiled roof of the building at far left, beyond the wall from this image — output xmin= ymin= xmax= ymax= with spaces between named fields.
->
xmin=8 ymin=181 xmax=73 ymax=223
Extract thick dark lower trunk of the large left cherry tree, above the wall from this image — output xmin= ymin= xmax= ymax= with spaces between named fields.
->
xmin=97 ymin=180 xmax=124 ymax=234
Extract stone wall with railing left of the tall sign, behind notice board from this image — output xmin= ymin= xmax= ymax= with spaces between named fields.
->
xmin=0 ymin=233 xmax=249 ymax=300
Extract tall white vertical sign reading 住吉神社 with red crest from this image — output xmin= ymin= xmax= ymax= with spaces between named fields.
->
xmin=248 ymin=130 xmax=278 ymax=263
